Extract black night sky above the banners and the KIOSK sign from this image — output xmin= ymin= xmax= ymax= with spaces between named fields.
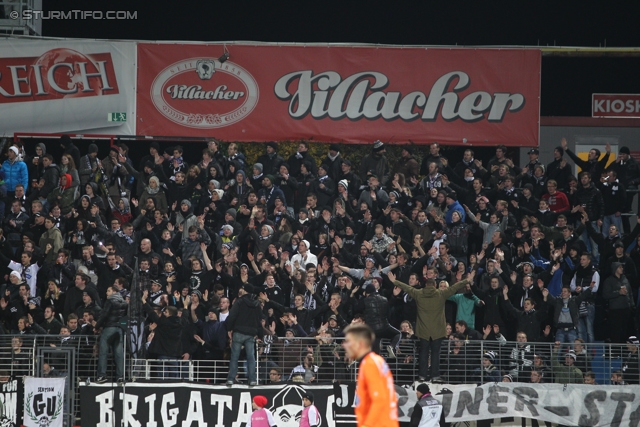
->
xmin=43 ymin=0 xmax=640 ymax=116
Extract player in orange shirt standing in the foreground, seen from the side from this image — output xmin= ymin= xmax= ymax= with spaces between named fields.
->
xmin=343 ymin=324 xmax=399 ymax=427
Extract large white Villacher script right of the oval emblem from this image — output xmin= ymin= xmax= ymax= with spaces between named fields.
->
xmin=274 ymin=70 xmax=525 ymax=122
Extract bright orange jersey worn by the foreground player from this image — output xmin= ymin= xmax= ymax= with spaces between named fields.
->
xmin=355 ymin=352 xmax=399 ymax=427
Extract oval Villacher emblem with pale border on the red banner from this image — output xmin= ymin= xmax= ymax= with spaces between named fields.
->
xmin=151 ymin=58 xmax=259 ymax=129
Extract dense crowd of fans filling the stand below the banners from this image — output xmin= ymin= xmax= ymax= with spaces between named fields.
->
xmin=0 ymin=136 xmax=640 ymax=385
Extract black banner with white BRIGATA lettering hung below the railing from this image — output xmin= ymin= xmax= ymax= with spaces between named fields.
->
xmin=80 ymin=382 xmax=336 ymax=427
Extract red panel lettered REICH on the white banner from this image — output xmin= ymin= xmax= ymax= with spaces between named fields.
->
xmin=0 ymin=48 xmax=119 ymax=104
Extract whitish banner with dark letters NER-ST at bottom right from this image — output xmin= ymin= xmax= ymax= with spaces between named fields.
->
xmin=432 ymin=383 xmax=640 ymax=427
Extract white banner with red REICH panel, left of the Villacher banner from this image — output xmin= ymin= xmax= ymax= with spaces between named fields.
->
xmin=0 ymin=39 xmax=137 ymax=136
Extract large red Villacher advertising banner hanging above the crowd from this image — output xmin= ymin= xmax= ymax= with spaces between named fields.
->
xmin=137 ymin=43 xmax=541 ymax=146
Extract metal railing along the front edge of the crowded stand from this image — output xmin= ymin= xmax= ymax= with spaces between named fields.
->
xmin=0 ymin=335 xmax=640 ymax=419
